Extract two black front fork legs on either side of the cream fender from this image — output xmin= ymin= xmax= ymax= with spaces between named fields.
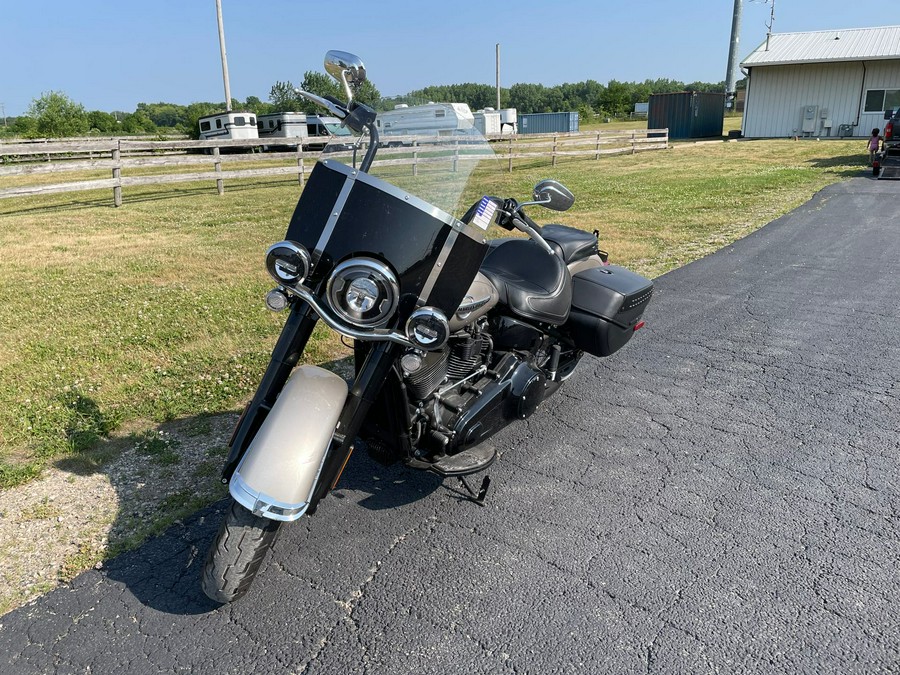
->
xmin=222 ymin=302 xmax=398 ymax=513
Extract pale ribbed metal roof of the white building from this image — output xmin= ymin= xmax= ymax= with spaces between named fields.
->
xmin=741 ymin=26 xmax=900 ymax=68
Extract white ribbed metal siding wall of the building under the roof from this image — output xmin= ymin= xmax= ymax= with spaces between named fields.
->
xmin=743 ymin=61 xmax=900 ymax=138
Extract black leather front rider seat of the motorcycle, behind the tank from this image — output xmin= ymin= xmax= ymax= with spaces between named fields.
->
xmin=481 ymin=239 xmax=572 ymax=325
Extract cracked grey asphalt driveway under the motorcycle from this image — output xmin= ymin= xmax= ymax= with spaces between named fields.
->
xmin=0 ymin=178 xmax=900 ymax=675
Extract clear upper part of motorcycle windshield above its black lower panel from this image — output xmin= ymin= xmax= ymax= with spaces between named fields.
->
xmin=322 ymin=103 xmax=494 ymax=218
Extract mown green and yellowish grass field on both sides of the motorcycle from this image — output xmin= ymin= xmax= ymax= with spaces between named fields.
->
xmin=0 ymin=136 xmax=865 ymax=487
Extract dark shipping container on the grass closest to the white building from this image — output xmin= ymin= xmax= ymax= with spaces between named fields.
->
xmin=647 ymin=91 xmax=725 ymax=139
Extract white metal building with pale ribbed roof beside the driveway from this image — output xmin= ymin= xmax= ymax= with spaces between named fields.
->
xmin=741 ymin=26 xmax=900 ymax=138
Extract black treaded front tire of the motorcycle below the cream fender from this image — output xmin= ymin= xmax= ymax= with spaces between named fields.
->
xmin=200 ymin=500 xmax=281 ymax=604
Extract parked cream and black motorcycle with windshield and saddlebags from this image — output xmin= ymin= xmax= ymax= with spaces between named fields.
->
xmin=202 ymin=51 xmax=653 ymax=603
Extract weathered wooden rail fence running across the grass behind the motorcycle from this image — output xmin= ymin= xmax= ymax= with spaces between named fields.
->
xmin=0 ymin=129 xmax=668 ymax=206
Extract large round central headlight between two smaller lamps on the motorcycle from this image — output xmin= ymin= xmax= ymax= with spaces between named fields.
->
xmin=327 ymin=258 xmax=400 ymax=327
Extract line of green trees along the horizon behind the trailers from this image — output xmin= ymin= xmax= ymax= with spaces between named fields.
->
xmin=0 ymin=71 xmax=745 ymax=138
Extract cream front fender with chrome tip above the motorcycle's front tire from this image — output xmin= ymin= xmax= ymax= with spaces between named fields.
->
xmin=229 ymin=366 xmax=347 ymax=521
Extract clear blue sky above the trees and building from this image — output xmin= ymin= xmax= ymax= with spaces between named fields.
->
xmin=0 ymin=0 xmax=891 ymax=115
